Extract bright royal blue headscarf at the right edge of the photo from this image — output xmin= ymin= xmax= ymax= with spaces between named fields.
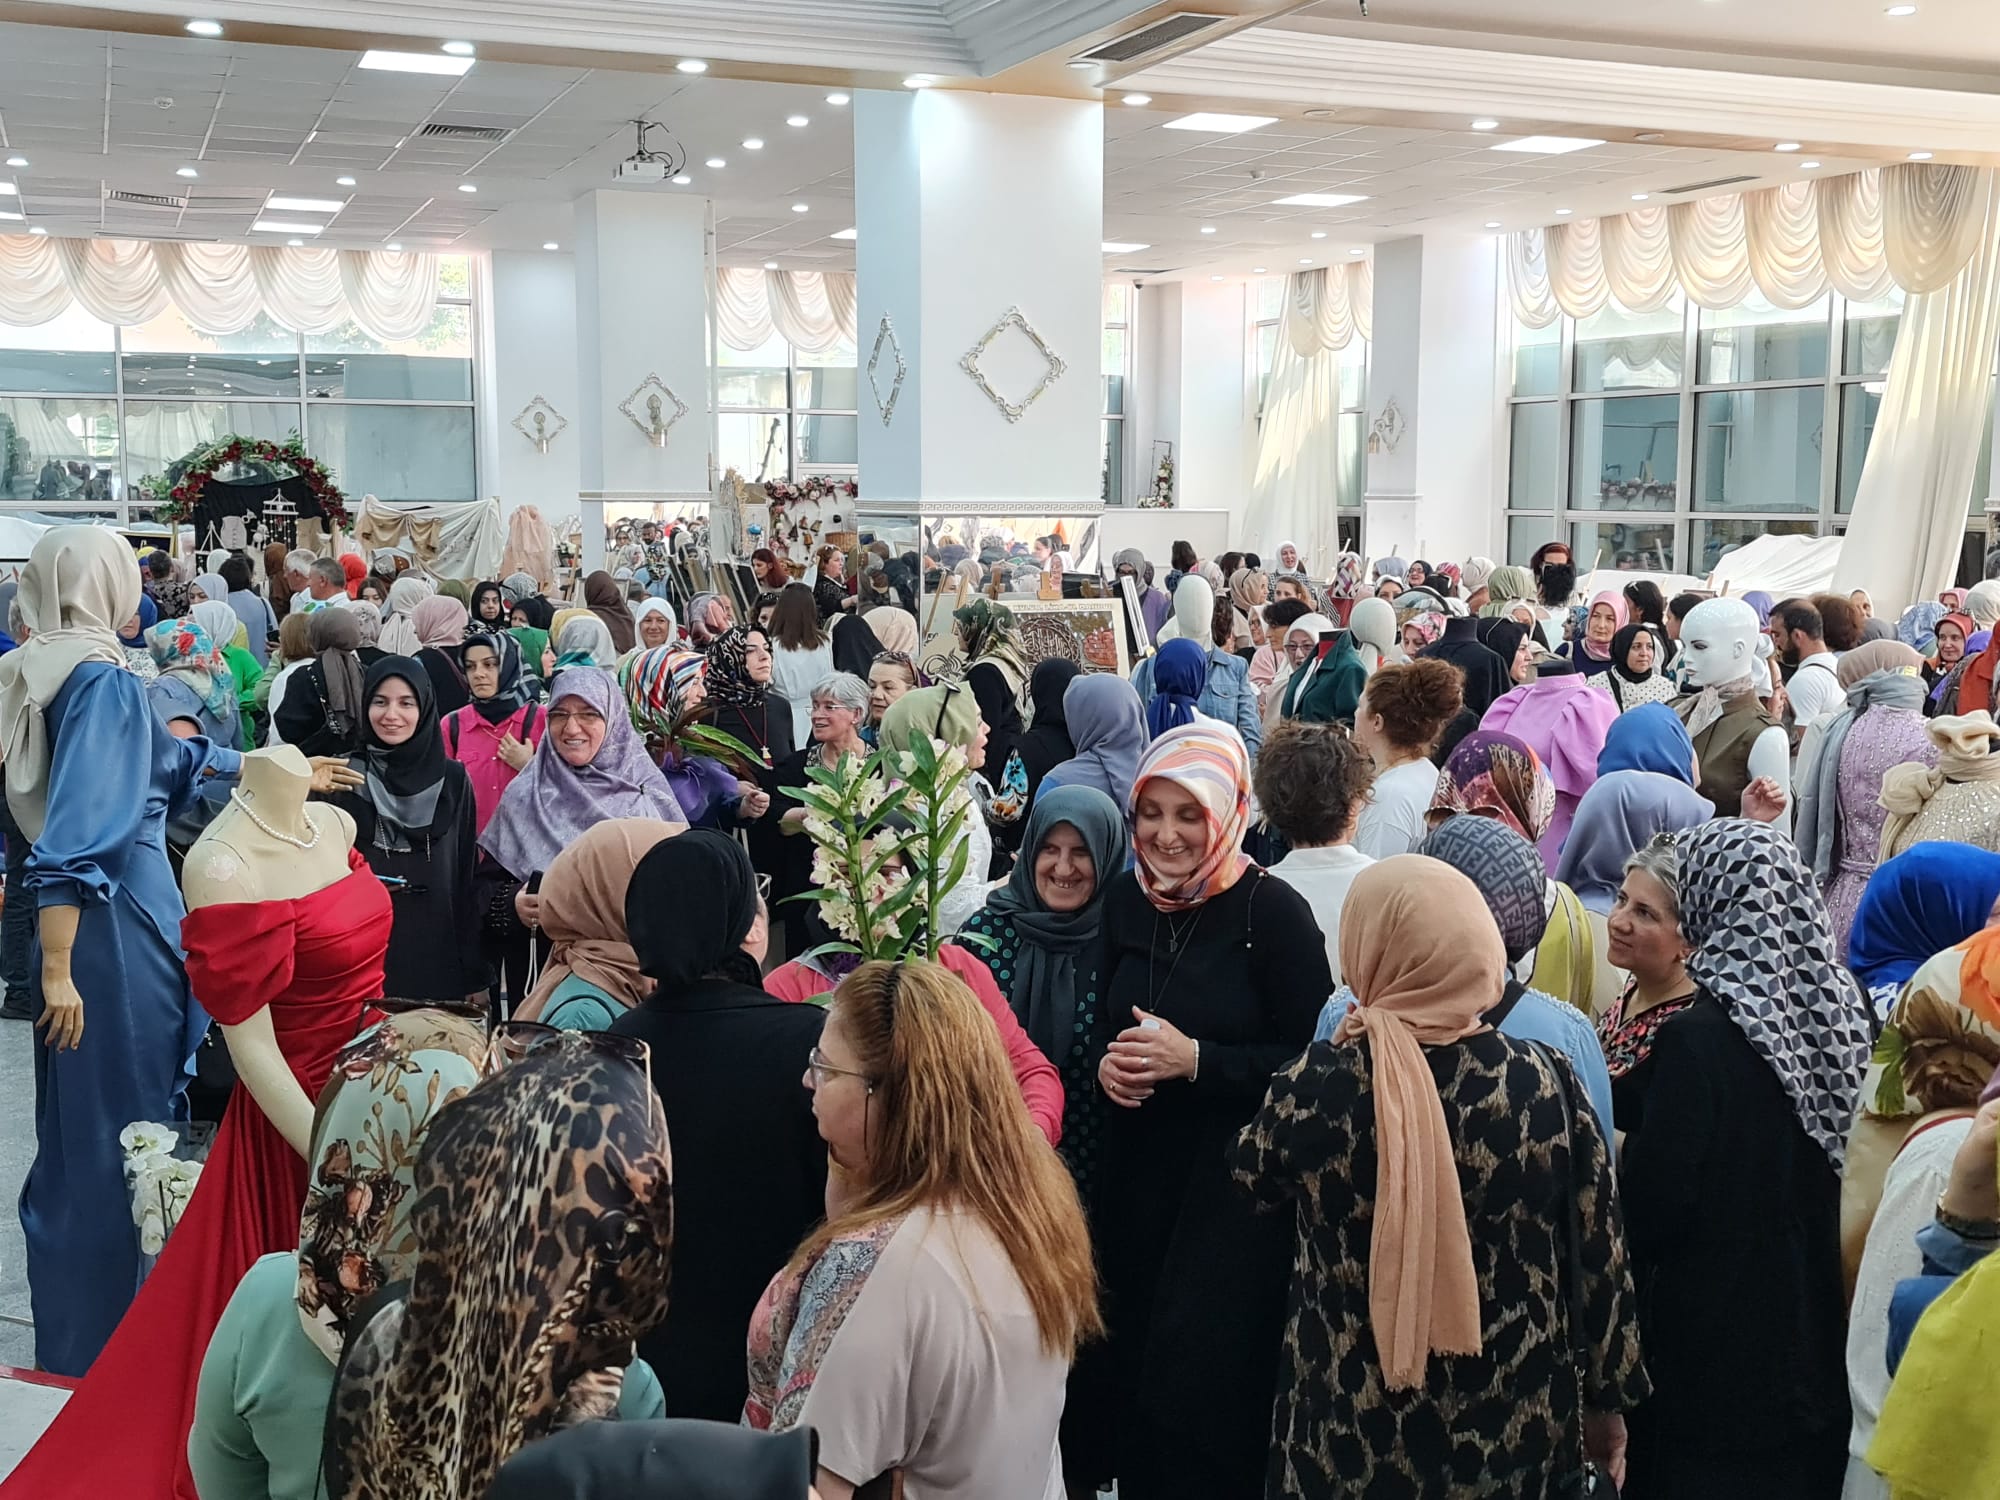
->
xmin=1848 ymin=840 xmax=2000 ymax=990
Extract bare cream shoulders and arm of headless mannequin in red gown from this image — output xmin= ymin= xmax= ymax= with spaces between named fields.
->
xmin=180 ymin=744 xmax=354 ymax=1156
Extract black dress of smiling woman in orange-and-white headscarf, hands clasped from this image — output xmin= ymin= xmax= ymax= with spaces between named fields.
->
xmin=1088 ymin=868 xmax=1334 ymax=1500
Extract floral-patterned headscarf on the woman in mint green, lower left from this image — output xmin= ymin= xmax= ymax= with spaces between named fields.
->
xmin=296 ymin=1010 xmax=486 ymax=1364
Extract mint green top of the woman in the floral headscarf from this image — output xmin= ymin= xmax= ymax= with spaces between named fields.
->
xmin=188 ymin=1252 xmax=666 ymax=1500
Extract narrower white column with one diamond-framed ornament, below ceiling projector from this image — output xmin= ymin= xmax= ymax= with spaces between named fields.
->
xmin=572 ymin=190 xmax=712 ymax=568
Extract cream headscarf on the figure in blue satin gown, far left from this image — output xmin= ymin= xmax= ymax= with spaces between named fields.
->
xmin=0 ymin=526 xmax=140 ymax=840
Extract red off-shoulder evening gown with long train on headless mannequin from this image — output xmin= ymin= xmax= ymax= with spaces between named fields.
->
xmin=0 ymin=852 xmax=390 ymax=1500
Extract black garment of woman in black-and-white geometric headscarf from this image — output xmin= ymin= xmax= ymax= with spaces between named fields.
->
xmin=1618 ymin=994 xmax=1850 ymax=1500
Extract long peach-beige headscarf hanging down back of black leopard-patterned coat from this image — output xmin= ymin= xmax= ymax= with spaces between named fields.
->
xmin=1334 ymin=854 xmax=1506 ymax=1390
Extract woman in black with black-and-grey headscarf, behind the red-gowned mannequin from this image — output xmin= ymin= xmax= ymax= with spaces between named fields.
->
xmin=328 ymin=656 xmax=486 ymax=1008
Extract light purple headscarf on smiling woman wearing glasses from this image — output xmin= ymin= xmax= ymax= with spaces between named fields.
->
xmin=480 ymin=666 xmax=686 ymax=880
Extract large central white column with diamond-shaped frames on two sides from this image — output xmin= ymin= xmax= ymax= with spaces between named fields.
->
xmin=854 ymin=90 xmax=1104 ymax=514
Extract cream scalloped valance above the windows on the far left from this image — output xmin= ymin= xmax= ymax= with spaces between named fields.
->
xmin=0 ymin=234 xmax=438 ymax=342
